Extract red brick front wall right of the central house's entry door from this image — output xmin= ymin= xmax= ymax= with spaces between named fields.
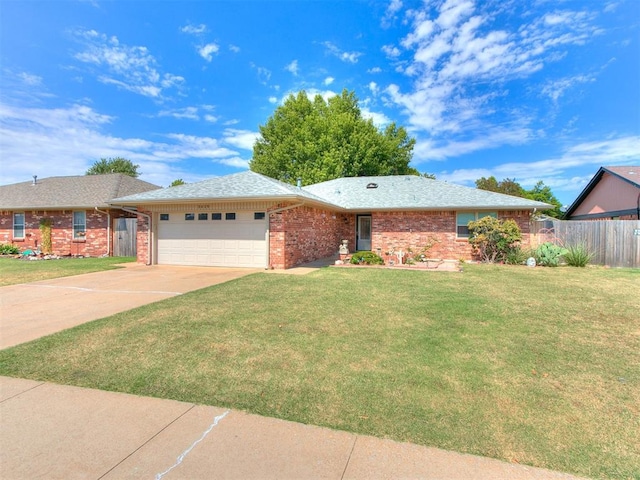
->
xmin=371 ymin=211 xmax=530 ymax=263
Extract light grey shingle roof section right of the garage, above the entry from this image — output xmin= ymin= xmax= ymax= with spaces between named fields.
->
xmin=304 ymin=175 xmax=551 ymax=210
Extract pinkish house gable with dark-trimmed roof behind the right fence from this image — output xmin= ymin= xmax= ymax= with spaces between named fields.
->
xmin=564 ymin=167 xmax=640 ymax=220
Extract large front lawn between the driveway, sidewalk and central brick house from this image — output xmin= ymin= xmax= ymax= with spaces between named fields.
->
xmin=0 ymin=265 xmax=640 ymax=479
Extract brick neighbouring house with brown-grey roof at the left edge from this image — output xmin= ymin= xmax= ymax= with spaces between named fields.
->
xmin=0 ymin=173 xmax=160 ymax=257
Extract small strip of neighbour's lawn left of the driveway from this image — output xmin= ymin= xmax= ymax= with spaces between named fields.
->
xmin=0 ymin=257 xmax=136 ymax=287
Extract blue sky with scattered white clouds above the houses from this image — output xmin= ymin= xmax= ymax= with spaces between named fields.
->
xmin=0 ymin=0 xmax=640 ymax=204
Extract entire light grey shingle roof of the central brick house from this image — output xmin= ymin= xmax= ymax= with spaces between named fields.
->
xmin=112 ymin=171 xmax=551 ymax=211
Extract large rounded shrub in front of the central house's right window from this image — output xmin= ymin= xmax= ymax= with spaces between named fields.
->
xmin=469 ymin=216 xmax=522 ymax=263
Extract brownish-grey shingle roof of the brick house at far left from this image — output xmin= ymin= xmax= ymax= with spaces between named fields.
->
xmin=0 ymin=173 xmax=160 ymax=210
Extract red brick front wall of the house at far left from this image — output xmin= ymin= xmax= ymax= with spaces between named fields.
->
xmin=0 ymin=210 xmax=113 ymax=257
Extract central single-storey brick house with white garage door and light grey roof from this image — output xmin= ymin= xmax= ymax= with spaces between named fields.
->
xmin=112 ymin=171 xmax=550 ymax=269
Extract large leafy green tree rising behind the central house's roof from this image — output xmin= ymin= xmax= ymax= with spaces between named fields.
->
xmin=249 ymin=90 xmax=418 ymax=185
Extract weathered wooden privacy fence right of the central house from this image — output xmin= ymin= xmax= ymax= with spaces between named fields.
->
xmin=531 ymin=220 xmax=640 ymax=268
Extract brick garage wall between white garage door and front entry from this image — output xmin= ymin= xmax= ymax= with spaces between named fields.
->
xmin=269 ymin=207 xmax=355 ymax=269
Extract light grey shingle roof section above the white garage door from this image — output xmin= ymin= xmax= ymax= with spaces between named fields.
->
xmin=111 ymin=170 xmax=326 ymax=205
